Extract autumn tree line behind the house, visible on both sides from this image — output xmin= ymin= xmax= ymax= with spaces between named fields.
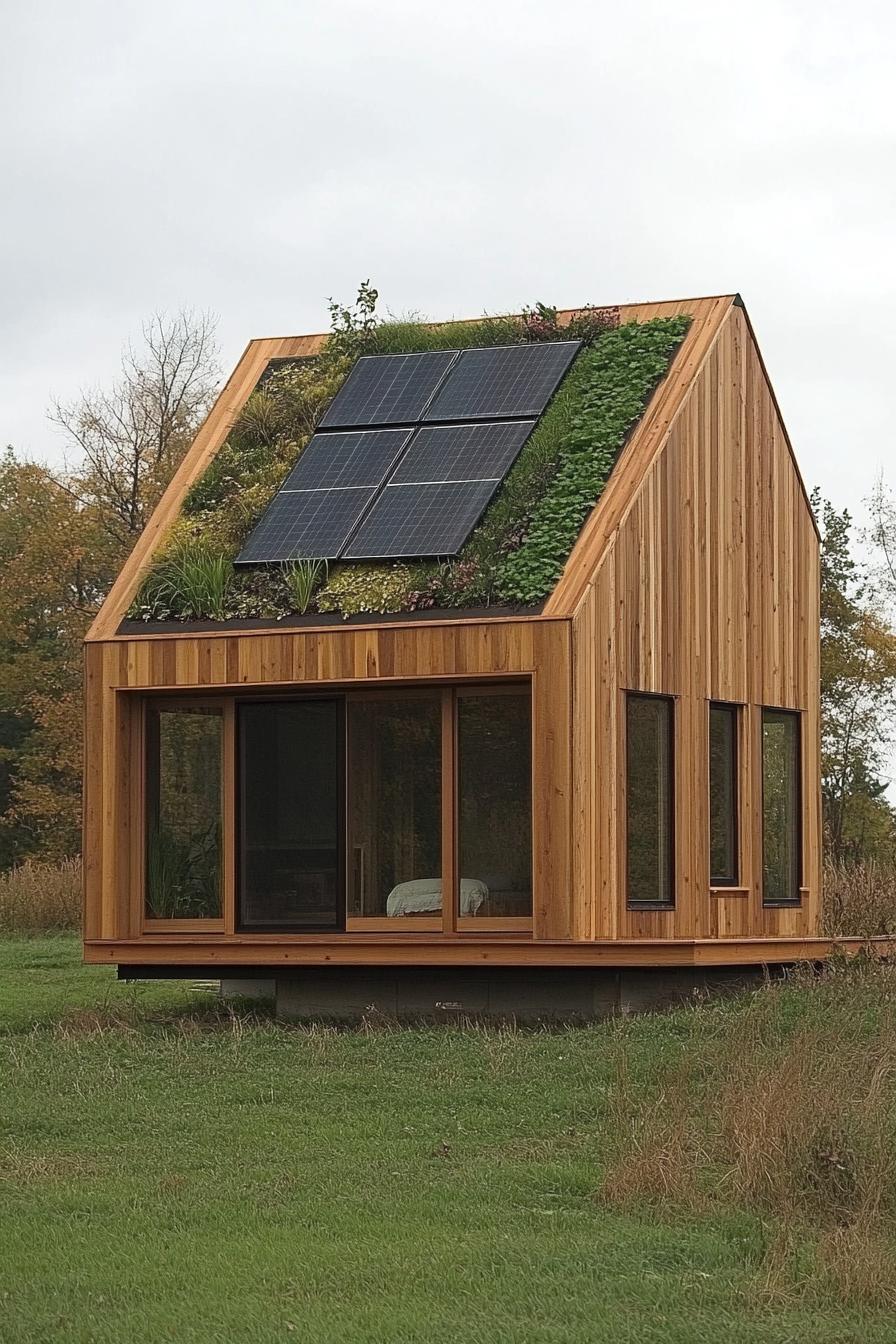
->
xmin=0 ymin=312 xmax=896 ymax=870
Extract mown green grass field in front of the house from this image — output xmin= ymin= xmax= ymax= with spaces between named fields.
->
xmin=0 ymin=937 xmax=896 ymax=1344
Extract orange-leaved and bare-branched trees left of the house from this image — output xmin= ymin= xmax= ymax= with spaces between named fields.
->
xmin=0 ymin=313 xmax=218 ymax=866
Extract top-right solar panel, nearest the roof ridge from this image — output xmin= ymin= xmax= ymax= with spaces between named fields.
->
xmin=422 ymin=340 xmax=582 ymax=422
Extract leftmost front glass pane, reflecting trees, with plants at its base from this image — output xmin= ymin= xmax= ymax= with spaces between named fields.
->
xmin=145 ymin=706 xmax=223 ymax=919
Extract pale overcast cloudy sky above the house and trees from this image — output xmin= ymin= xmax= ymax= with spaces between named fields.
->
xmin=0 ymin=0 xmax=896 ymax=534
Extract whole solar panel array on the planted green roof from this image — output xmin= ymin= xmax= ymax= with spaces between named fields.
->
xmin=236 ymin=341 xmax=580 ymax=564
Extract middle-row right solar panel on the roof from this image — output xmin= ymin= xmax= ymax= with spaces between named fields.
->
xmin=390 ymin=421 xmax=535 ymax=485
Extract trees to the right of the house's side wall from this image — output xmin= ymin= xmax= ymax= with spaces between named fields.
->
xmin=813 ymin=491 xmax=896 ymax=859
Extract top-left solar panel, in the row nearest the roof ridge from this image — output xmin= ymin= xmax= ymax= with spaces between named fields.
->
xmin=320 ymin=349 xmax=457 ymax=429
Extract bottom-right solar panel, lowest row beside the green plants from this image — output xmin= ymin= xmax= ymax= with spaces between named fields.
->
xmin=343 ymin=481 xmax=498 ymax=560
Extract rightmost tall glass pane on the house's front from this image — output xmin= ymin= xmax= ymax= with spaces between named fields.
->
xmin=457 ymin=688 xmax=532 ymax=918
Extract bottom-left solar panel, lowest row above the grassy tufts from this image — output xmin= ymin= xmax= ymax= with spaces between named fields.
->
xmin=235 ymin=485 xmax=376 ymax=564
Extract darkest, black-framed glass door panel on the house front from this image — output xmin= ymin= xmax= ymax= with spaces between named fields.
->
xmin=239 ymin=699 xmax=344 ymax=931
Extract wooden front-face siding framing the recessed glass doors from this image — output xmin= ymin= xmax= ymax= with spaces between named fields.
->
xmin=85 ymin=620 xmax=576 ymax=941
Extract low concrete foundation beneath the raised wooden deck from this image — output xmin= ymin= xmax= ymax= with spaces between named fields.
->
xmin=275 ymin=966 xmax=783 ymax=1023
